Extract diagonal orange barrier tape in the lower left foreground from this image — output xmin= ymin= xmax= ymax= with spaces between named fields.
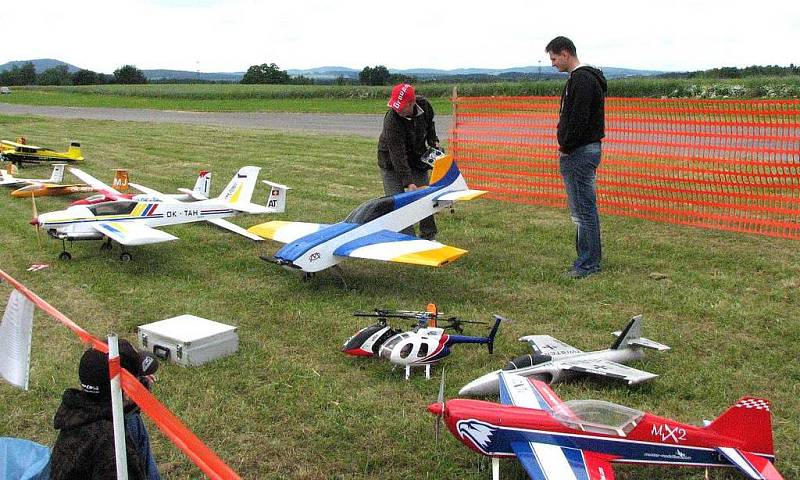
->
xmin=0 ymin=270 xmax=240 ymax=480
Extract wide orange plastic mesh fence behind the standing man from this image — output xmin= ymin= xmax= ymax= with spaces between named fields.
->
xmin=450 ymin=97 xmax=800 ymax=239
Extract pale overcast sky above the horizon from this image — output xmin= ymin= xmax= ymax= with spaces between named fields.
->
xmin=0 ymin=0 xmax=800 ymax=73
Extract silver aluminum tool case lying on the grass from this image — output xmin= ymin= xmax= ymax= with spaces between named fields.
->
xmin=136 ymin=315 xmax=239 ymax=367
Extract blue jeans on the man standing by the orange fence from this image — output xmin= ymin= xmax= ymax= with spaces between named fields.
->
xmin=559 ymin=142 xmax=602 ymax=274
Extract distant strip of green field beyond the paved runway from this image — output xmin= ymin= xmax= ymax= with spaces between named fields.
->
xmin=0 ymin=77 xmax=800 ymax=114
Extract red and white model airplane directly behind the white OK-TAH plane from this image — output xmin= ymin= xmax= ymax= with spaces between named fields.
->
xmin=69 ymin=168 xmax=206 ymax=205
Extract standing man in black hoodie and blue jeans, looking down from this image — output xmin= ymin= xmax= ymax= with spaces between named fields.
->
xmin=545 ymin=37 xmax=608 ymax=278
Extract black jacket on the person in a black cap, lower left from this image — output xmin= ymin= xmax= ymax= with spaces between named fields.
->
xmin=50 ymin=388 xmax=147 ymax=480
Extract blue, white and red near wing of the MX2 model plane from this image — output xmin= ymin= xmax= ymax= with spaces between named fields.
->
xmin=511 ymin=442 xmax=614 ymax=480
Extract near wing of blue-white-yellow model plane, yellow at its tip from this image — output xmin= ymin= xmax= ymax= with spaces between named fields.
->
xmin=333 ymin=230 xmax=467 ymax=267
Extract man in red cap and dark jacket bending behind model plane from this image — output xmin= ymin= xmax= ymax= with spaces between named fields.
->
xmin=378 ymin=83 xmax=439 ymax=240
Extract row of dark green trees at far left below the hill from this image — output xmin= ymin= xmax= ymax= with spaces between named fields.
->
xmin=0 ymin=62 xmax=147 ymax=86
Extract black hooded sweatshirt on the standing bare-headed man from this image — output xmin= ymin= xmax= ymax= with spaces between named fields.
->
xmin=558 ymin=66 xmax=608 ymax=153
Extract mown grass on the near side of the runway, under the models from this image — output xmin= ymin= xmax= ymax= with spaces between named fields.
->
xmin=0 ymin=116 xmax=800 ymax=480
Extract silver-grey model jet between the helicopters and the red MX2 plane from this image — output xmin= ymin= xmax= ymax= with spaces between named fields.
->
xmin=458 ymin=315 xmax=669 ymax=395
